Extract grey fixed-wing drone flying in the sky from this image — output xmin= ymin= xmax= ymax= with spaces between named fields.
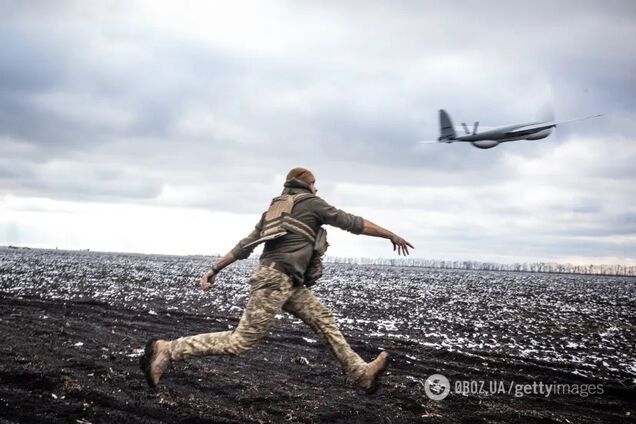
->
xmin=424 ymin=109 xmax=601 ymax=149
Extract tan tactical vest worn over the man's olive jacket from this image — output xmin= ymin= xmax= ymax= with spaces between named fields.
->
xmin=245 ymin=193 xmax=316 ymax=247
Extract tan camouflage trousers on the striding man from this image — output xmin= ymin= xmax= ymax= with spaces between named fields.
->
xmin=170 ymin=266 xmax=366 ymax=377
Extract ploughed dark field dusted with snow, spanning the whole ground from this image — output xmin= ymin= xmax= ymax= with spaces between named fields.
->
xmin=0 ymin=248 xmax=636 ymax=422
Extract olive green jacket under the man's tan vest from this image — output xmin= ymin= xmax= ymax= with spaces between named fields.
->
xmin=232 ymin=179 xmax=364 ymax=284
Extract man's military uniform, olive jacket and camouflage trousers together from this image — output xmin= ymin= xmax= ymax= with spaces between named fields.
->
xmin=170 ymin=179 xmax=367 ymax=379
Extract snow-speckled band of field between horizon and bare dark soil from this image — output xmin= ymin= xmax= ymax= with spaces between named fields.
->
xmin=0 ymin=248 xmax=636 ymax=381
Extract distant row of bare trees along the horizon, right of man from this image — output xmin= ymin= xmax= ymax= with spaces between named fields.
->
xmin=325 ymin=256 xmax=636 ymax=276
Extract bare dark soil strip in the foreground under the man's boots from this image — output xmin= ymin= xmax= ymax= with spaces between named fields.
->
xmin=0 ymin=296 xmax=636 ymax=423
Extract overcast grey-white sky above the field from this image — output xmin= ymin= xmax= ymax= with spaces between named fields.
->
xmin=0 ymin=0 xmax=636 ymax=265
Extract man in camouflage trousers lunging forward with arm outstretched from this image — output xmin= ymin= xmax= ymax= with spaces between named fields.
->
xmin=140 ymin=168 xmax=413 ymax=393
